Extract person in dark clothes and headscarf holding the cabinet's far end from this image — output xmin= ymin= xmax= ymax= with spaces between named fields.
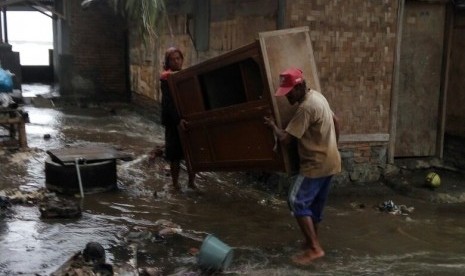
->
xmin=160 ymin=47 xmax=197 ymax=191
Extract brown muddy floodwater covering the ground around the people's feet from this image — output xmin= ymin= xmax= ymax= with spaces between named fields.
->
xmin=0 ymin=102 xmax=465 ymax=275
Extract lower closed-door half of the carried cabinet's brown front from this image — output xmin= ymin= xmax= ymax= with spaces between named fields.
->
xmin=181 ymin=101 xmax=283 ymax=171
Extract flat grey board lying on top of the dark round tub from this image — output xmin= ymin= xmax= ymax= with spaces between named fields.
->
xmin=47 ymin=145 xmax=132 ymax=165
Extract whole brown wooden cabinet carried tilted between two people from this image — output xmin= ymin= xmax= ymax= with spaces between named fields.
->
xmin=168 ymin=28 xmax=319 ymax=173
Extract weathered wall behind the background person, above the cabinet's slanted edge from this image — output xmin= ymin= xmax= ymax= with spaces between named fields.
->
xmin=130 ymin=0 xmax=277 ymax=101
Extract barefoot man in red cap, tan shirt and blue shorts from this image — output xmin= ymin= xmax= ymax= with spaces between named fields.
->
xmin=265 ymin=68 xmax=341 ymax=265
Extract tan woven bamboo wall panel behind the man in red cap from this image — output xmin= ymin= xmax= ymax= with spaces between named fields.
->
xmin=285 ymin=0 xmax=398 ymax=134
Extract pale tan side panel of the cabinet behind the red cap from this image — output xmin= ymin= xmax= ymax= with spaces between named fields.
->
xmin=259 ymin=27 xmax=321 ymax=174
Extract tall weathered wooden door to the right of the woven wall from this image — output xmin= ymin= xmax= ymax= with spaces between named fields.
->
xmin=395 ymin=1 xmax=445 ymax=157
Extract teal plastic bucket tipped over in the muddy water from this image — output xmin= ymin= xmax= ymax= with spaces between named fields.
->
xmin=198 ymin=234 xmax=233 ymax=271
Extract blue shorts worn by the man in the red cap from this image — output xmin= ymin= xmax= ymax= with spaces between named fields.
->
xmin=288 ymin=175 xmax=332 ymax=222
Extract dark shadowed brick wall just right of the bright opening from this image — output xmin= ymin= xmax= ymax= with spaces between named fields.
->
xmin=66 ymin=1 xmax=128 ymax=98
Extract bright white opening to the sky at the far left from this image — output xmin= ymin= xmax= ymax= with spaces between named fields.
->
xmin=3 ymin=11 xmax=53 ymax=65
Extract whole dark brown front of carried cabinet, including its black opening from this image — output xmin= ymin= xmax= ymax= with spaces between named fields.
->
xmin=168 ymin=41 xmax=284 ymax=172
